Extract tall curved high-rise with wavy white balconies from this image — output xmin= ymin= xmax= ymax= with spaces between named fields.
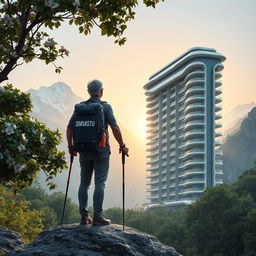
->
xmin=144 ymin=47 xmax=225 ymax=207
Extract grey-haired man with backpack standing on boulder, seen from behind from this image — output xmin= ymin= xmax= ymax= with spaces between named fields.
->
xmin=66 ymin=80 xmax=128 ymax=226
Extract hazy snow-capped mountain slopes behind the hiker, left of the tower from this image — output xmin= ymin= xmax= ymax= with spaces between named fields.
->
xmin=28 ymin=82 xmax=146 ymax=208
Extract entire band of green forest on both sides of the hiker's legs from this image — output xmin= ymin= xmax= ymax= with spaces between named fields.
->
xmin=0 ymin=167 xmax=256 ymax=256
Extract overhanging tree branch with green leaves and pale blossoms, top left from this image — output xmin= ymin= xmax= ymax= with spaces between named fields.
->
xmin=0 ymin=0 xmax=164 ymax=83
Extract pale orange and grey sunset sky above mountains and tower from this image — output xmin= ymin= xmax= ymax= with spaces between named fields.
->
xmin=6 ymin=0 xmax=256 ymax=140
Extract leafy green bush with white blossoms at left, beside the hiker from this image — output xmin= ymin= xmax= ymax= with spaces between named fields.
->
xmin=0 ymin=85 xmax=66 ymax=191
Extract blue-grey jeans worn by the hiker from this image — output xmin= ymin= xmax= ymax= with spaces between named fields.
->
xmin=78 ymin=152 xmax=109 ymax=217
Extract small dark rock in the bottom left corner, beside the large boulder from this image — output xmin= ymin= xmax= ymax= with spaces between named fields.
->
xmin=0 ymin=228 xmax=25 ymax=253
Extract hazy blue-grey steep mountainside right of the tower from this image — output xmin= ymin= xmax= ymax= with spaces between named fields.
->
xmin=222 ymin=107 xmax=256 ymax=184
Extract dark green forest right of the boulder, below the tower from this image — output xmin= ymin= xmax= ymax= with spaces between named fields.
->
xmin=105 ymin=167 xmax=256 ymax=256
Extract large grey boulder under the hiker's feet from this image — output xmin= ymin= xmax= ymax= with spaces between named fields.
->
xmin=5 ymin=224 xmax=180 ymax=256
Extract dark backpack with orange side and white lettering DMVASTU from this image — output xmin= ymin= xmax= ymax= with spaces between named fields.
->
xmin=73 ymin=100 xmax=106 ymax=152
